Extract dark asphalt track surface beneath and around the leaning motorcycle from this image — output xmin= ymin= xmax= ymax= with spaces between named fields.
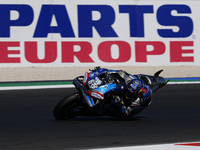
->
xmin=0 ymin=84 xmax=200 ymax=150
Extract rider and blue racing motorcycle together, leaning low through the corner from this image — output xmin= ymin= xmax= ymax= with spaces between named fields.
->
xmin=53 ymin=67 xmax=169 ymax=120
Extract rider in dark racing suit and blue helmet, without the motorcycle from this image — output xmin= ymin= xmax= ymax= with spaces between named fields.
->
xmin=100 ymin=67 xmax=152 ymax=116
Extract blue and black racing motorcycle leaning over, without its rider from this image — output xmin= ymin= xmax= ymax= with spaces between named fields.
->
xmin=53 ymin=67 xmax=169 ymax=120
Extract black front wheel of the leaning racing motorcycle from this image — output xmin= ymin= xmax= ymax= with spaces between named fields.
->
xmin=53 ymin=94 xmax=79 ymax=120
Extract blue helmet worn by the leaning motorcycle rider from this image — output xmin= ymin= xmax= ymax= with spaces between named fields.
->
xmin=125 ymin=79 xmax=144 ymax=99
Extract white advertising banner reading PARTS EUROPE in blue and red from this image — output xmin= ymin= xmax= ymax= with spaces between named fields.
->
xmin=0 ymin=0 xmax=200 ymax=67
